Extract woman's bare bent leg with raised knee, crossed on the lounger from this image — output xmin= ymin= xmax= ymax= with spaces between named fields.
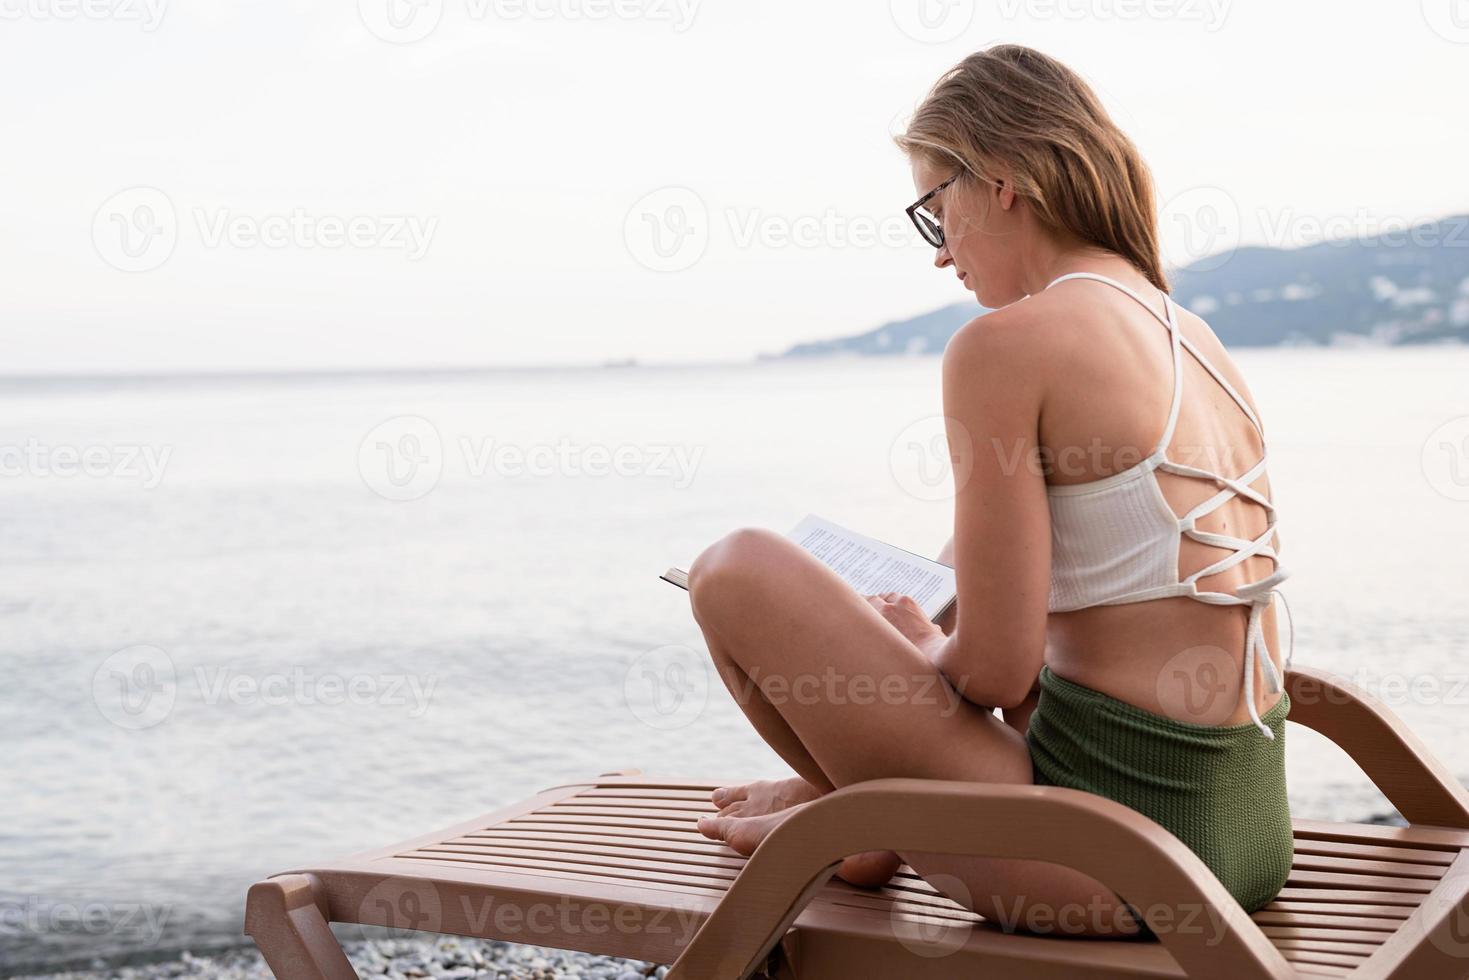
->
xmin=689 ymin=527 xmax=1136 ymax=936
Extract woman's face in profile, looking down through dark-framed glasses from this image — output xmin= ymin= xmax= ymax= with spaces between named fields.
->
xmin=912 ymin=156 xmax=1025 ymax=309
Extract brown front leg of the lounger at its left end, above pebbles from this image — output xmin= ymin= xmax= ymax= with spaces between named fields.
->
xmin=245 ymin=874 xmax=357 ymax=980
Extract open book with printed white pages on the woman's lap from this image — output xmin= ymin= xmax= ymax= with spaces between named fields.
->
xmin=658 ymin=514 xmax=958 ymax=620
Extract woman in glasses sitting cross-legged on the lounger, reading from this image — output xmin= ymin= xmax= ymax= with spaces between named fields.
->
xmin=689 ymin=46 xmax=1291 ymax=936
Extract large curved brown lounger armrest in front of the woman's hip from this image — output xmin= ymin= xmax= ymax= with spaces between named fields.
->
xmin=668 ymin=779 xmax=1294 ymax=980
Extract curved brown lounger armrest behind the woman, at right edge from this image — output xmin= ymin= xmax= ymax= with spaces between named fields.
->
xmin=1285 ymin=667 xmax=1469 ymax=829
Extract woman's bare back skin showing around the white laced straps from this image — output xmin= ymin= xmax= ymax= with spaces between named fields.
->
xmin=1025 ymin=271 xmax=1279 ymax=724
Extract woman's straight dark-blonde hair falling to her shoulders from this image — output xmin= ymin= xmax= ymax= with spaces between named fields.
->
xmin=896 ymin=44 xmax=1168 ymax=292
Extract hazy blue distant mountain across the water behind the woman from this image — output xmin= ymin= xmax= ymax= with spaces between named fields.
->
xmin=777 ymin=215 xmax=1469 ymax=357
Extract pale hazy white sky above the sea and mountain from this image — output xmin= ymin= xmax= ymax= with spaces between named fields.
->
xmin=0 ymin=0 xmax=1469 ymax=373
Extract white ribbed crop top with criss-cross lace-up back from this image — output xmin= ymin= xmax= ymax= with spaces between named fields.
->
xmin=1046 ymin=272 xmax=1296 ymax=739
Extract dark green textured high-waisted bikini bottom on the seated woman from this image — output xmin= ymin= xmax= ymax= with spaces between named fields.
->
xmin=1025 ymin=667 xmax=1294 ymax=912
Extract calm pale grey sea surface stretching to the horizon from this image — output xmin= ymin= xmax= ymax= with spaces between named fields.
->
xmin=0 ymin=348 xmax=1469 ymax=970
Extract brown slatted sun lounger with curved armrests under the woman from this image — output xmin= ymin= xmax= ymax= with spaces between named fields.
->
xmin=245 ymin=669 xmax=1469 ymax=980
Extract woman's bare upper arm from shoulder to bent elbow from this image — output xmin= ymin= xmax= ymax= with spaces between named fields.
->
xmin=933 ymin=314 xmax=1050 ymax=708
